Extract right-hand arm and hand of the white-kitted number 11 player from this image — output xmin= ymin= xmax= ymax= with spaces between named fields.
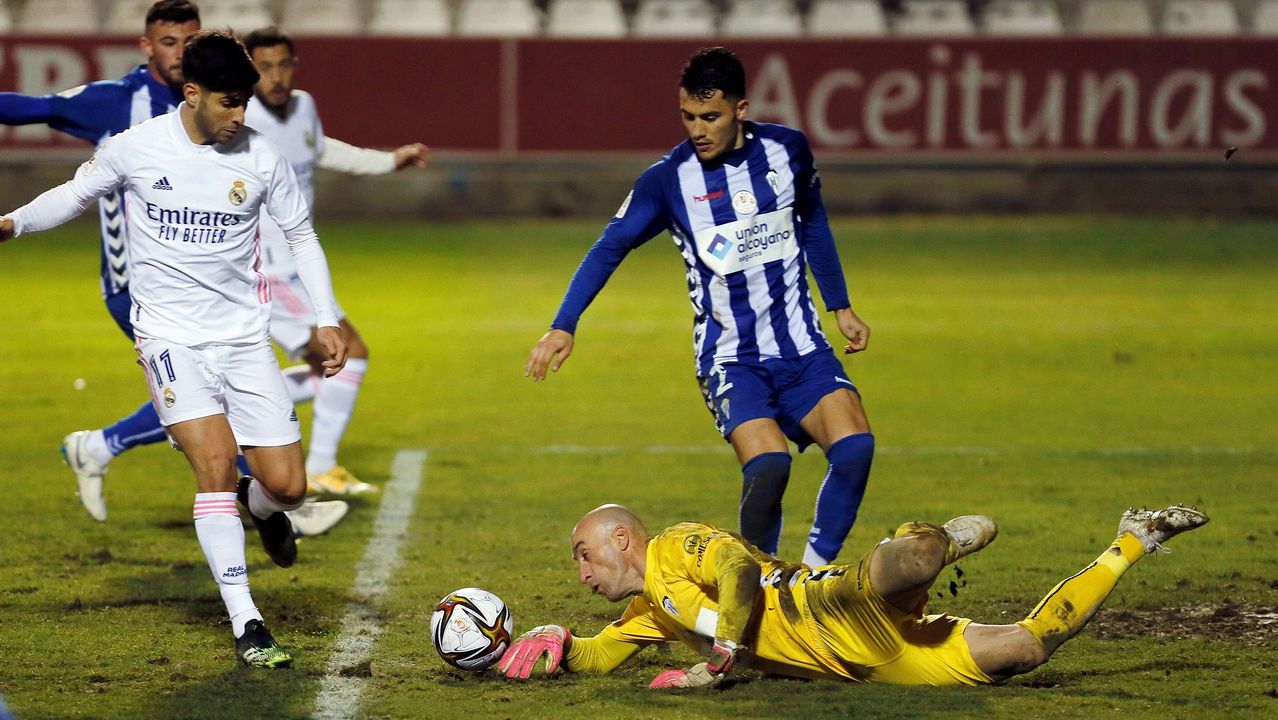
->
xmin=263 ymin=156 xmax=346 ymax=377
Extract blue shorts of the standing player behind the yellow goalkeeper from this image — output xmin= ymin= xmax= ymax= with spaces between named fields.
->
xmin=697 ymin=349 xmax=860 ymax=451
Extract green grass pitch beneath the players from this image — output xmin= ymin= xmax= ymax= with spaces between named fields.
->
xmin=0 ymin=216 xmax=1278 ymax=720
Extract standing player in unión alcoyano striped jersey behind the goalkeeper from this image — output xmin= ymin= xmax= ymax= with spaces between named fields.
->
xmin=524 ymin=47 xmax=874 ymax=567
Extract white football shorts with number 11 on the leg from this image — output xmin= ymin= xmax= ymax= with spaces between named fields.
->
xmin=137 ymin=339 xmax=302 ymax=448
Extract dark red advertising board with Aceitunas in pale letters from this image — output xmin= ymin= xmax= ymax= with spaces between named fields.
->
xmin=0 ymin=37 xmax=1278 ymax=156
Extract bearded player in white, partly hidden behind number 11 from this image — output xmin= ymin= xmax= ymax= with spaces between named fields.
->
xmin=244 ymin=27 xmax=429 ymax=495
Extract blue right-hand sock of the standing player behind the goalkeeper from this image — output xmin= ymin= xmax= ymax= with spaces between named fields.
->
xmin=808 ymin=432 xmax=874 ymax=561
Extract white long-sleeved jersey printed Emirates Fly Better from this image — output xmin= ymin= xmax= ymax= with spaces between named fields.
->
xmin=10 ymin=111 xmax=337 ymax=345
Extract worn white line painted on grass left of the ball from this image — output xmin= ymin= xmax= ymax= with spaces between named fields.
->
xmin=311 ymin=450 xmax=426 ymax=720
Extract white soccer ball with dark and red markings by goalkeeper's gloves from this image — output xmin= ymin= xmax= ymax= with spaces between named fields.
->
xmin=431 ymin=587 xmax=515 ymax=673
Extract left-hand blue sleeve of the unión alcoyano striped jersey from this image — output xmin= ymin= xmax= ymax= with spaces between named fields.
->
xmin=551 ymin=161 xmax=670 ymax=333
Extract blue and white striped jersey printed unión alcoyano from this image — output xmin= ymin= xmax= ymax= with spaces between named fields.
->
xmin=551 ymin=123 xmax=850 ymax=376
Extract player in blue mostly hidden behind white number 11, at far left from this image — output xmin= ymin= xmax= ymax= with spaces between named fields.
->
xmin=0 ymin=0 xmax=199 ymax=520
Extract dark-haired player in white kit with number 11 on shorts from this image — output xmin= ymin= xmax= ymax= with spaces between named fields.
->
xmin=0 ymin=32 xmax=346 ymax=668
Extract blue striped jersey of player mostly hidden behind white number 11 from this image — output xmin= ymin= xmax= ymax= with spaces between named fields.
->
xmin=0 ymin=65 xmax=181 ymax=298
